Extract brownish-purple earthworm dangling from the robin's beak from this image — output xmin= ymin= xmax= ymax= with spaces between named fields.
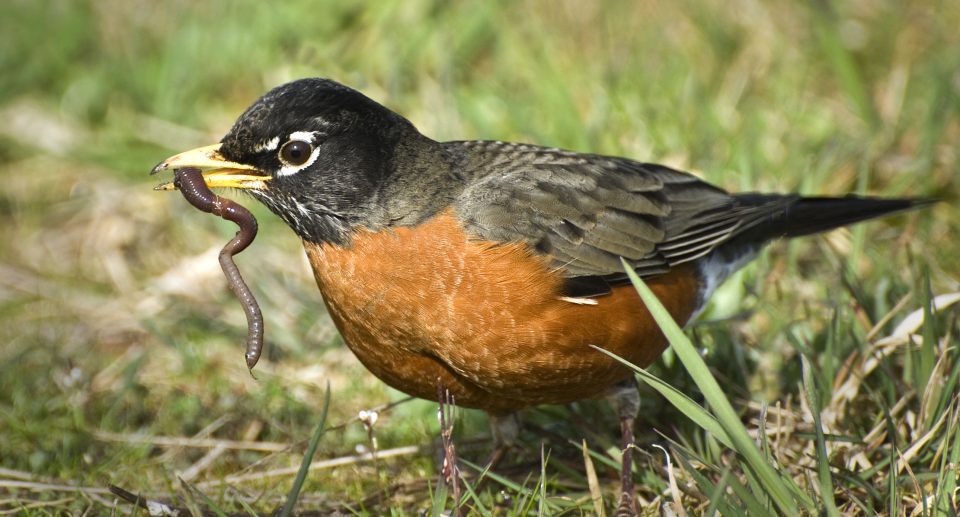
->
xmin=173 ymin=167 xmax=263 ymax=370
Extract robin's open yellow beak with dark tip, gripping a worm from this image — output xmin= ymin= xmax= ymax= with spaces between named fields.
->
xmin=150 ymin=144 xmax=271 ymax=190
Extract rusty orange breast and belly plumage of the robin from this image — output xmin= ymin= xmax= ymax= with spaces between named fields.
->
xmin=305 ymin=211 xmax=699 ymax=413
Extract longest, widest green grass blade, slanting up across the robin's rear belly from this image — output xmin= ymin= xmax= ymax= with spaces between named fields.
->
xmin=621 ymin=259 xmax=816 ymax=515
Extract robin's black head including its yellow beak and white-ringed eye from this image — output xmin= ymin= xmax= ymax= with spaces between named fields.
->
xmin=153 ymin=79 xmax=422 ymax=242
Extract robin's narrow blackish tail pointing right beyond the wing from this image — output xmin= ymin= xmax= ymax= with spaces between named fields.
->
xmin=735 ymin=193 xmax=936 ymax=242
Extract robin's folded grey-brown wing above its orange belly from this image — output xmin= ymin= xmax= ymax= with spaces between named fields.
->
xmin=447 ymin=142 xmax=783 ymax=280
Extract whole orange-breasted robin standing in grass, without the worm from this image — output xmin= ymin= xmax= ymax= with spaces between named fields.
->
xmin=152 ymin=78 xmax=927 ymax=507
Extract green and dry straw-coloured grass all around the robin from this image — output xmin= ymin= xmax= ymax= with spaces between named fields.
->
xmin=0 ymin=0 xmax=960 ymax=515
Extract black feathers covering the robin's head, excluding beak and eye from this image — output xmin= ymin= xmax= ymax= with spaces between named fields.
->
xmin=214 ymin=78 xmax=454 ymax=244
